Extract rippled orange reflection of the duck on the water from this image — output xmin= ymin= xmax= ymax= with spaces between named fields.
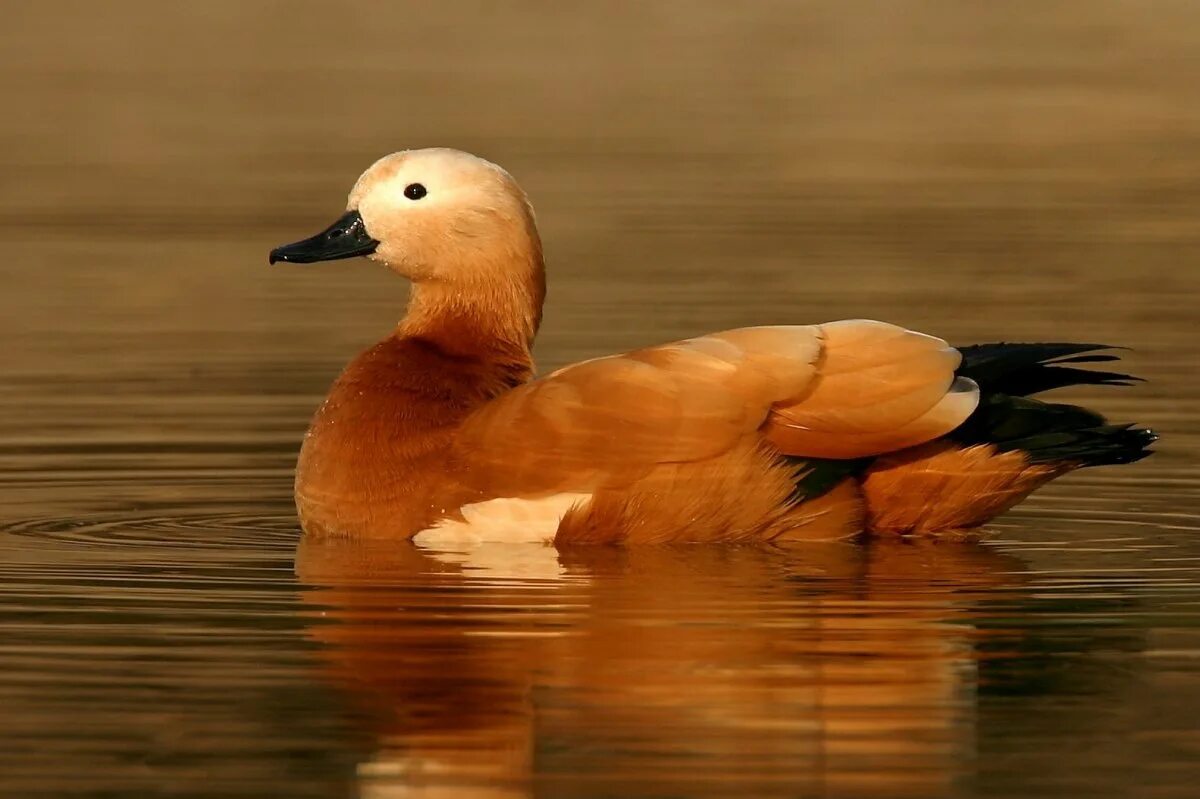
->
xmin=298 ymin=541 xmax=1021 ymax=797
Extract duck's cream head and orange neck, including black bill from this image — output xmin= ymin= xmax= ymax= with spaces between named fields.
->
xmin=269 ymin=149 xmax=546 ymax=347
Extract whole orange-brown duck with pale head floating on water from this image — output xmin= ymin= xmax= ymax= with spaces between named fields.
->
xmin=269 ymin=148 xmax=1157 ymax=547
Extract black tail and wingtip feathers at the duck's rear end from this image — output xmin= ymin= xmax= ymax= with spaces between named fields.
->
xmin=952 ymin=343 xmax=1158 ymax=465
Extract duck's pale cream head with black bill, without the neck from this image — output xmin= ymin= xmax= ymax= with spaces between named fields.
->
xmin=270 ymin=148 xmax=541 ymax=289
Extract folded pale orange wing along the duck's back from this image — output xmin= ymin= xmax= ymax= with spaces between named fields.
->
xmin=457 ymin=320 xmax=978 ymax=493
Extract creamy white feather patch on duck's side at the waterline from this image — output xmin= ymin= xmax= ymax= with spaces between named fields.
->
xmin=413 ymin=492 xmax=592 ymax=549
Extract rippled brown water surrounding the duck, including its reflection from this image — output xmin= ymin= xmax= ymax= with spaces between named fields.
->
xmin=0 ymin=0 xmax=1200 ymax=798
